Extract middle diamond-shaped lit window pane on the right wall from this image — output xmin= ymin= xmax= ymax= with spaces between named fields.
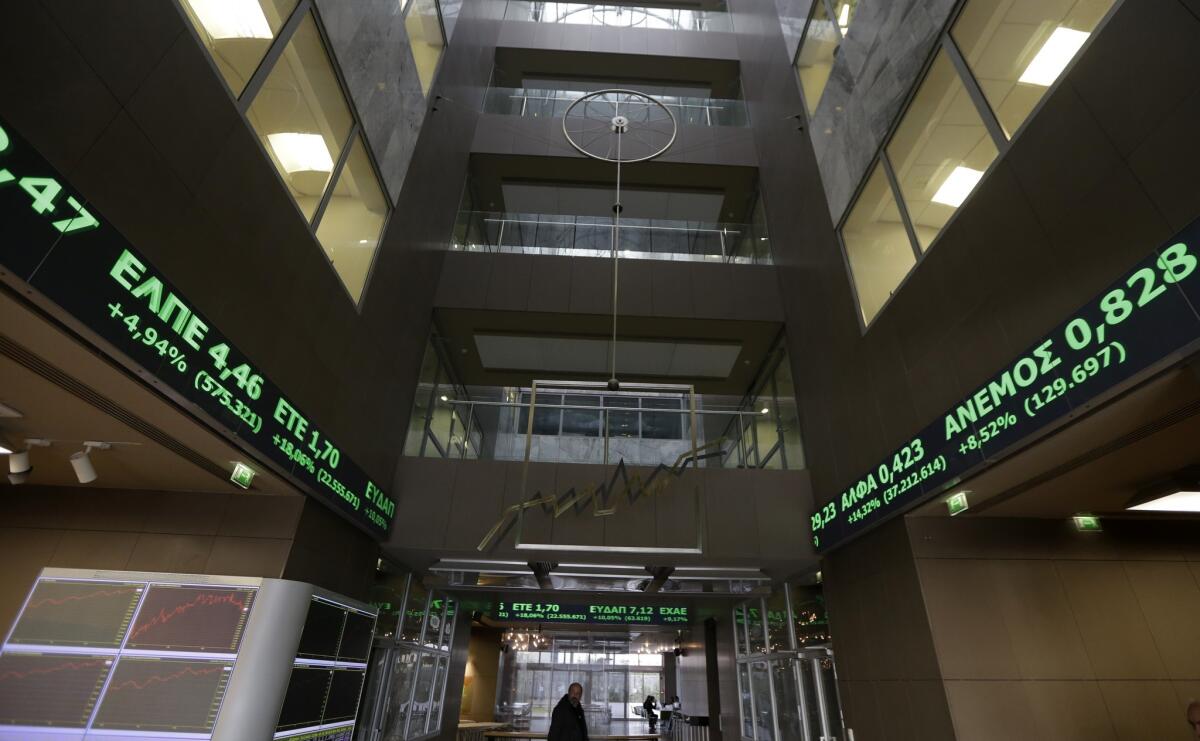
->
xmin=888 ymin=50 xmax=1000 ymax=251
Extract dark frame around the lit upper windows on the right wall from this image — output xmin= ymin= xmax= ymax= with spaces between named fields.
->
xmin=835 ymin=0 xmax=1124 ymax=336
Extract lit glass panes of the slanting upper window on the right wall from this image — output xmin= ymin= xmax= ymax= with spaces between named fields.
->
xmin=835 ymin=0 xmax=1116 ymax=330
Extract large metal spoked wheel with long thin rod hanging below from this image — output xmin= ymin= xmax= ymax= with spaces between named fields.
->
xmin=563 ymin=89 xmax=678 ymax=391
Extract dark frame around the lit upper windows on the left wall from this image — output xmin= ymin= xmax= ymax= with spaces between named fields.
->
xmin=174 ymin=0 xmax=398 ymax=314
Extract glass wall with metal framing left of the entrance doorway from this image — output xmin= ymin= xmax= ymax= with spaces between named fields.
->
xmin=355 ymin=573 xmax=458 ymax=741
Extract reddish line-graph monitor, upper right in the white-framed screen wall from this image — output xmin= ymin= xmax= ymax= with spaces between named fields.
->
xmin=125 ymin=584 xmax=254 ymax=653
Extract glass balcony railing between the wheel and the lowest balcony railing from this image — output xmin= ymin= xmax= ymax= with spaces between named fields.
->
xmin=452 ymin=211 xmax=772 ymax=265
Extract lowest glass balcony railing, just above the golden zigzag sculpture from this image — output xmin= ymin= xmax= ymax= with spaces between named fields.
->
xmin=406 ymin=385 xmax=804 ymax=469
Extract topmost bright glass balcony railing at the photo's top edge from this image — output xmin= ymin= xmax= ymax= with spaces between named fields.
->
xmin=504 ymin=0 xmax=733 ymax=31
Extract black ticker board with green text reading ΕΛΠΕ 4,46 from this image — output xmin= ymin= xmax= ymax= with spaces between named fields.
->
xmin=0 ymin=116 xmax=396 ymax=540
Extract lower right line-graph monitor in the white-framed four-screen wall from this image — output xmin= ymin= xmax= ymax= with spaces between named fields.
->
xmin=91 ymin=656 xmax=233 ymax=733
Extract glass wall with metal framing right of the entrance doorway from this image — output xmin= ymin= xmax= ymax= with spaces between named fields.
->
xmin=732 ymin=584 xmax=845 ymax=741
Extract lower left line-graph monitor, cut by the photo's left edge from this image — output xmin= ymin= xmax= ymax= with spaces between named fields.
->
xmin=0 ymin=652 xmax=113 ymax=728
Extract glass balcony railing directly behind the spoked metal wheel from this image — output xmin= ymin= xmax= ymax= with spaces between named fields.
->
xmin=484 ymin=88 xmax=750 ymax=126
